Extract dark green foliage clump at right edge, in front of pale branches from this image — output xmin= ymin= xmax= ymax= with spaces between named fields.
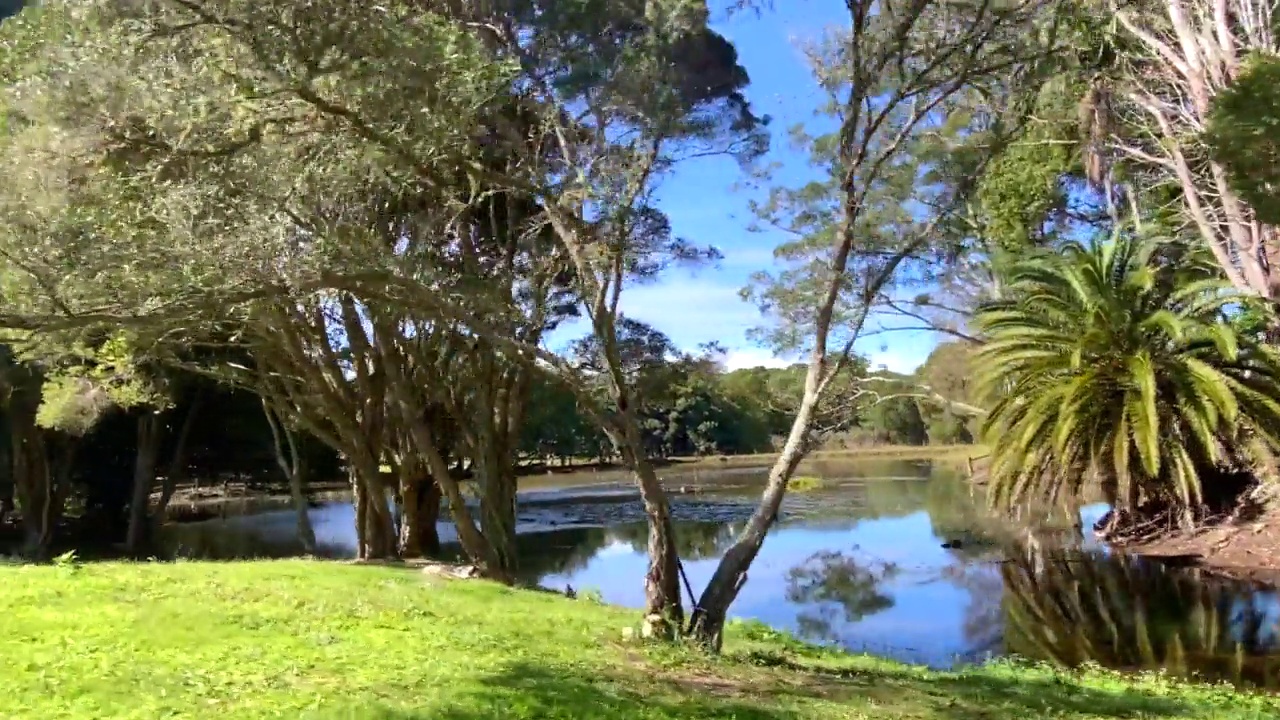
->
xmin=1204 ymin=53 xmax=1280 ymax=224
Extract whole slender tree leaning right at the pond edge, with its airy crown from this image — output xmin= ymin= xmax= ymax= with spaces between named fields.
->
xmin=691 ymin=0 xmax=1057 ymax=647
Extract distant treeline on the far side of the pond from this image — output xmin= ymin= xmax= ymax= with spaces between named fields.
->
xmin=521 ymin=342 xmax=975 ymax=465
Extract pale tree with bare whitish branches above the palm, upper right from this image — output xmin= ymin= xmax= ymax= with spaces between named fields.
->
xmin=1100 ymin=0 xmax=1280 ymax=297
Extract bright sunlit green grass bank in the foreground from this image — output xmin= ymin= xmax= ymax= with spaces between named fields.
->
xmin=0 ymin=561 xmax=1280 ymax=720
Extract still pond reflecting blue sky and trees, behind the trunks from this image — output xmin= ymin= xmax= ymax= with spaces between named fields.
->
xmin=166 ymin=461 xmax=1280 ymax=688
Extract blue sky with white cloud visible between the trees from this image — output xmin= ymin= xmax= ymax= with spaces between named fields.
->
xmin=540 ymin=0 xmax=937 ymax=372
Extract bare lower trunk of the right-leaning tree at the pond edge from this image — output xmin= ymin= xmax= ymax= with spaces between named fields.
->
xmin=690 ymin=364 xmax=820 ymax=651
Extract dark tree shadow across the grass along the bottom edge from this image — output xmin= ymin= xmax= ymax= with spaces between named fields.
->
xmin=370 ymin=650 xmax=1208 ymax=720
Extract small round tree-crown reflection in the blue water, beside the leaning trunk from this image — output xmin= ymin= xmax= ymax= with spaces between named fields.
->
xmin=787 ymin=551 xmax=897 ymax=643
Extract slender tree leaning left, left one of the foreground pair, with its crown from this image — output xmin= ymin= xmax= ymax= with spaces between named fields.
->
xmin=467 ymin=0 xmax=765 ymax=634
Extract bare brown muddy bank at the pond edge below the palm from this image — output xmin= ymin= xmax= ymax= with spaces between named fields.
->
xmin=1111 ymin=507 xmax=1280 ymax=585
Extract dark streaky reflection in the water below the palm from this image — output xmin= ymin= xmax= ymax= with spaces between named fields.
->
xmin=1001 ymin=547 xmax=1280 ymax=689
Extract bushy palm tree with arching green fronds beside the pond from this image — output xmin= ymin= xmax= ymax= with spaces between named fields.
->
xmin=977 ymin=236 xmax=1280 ymax=530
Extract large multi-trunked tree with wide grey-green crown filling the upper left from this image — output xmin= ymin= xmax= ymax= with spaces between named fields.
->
xmin=5 ymin=0 xmax=545 ymax=574
